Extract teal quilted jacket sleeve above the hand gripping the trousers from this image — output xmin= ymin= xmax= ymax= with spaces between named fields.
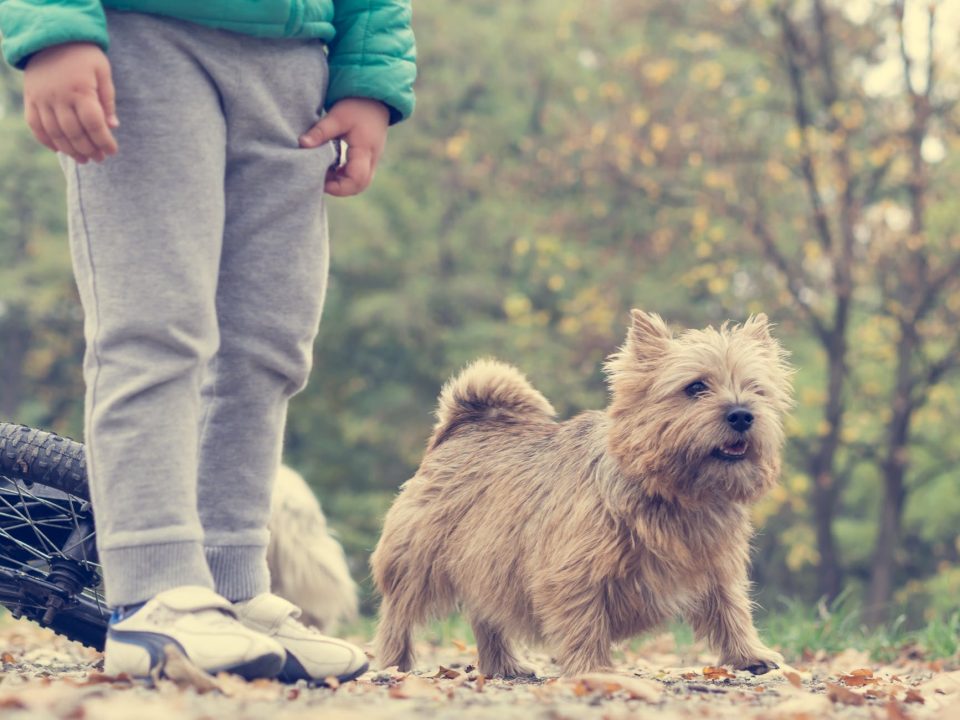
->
xmin=326 ymin=0 xmax=417 ymax=124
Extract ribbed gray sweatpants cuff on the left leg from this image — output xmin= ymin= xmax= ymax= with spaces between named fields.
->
xmin=100 ymin=540 xmax=213 ymax=607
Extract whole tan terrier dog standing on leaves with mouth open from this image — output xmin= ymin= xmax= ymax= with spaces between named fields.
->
xmin=371 ymin=310 xmax=792 ymax=677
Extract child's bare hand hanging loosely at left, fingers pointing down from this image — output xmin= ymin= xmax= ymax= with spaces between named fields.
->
xmin=23 ymin=42 xmax=120 ymax=164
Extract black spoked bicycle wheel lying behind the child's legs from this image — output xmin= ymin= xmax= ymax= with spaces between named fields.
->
xmin=0 ymin=423 xmax=109 ymax=650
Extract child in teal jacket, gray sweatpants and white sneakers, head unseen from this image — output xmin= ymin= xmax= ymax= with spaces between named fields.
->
xmin=0 ymin=0 xmax=415 ymax=681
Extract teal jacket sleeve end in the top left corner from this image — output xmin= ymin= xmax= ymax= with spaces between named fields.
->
xmin=0 ymin=0 xmax=108 ymax=70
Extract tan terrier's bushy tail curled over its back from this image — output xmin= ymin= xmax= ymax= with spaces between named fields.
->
xmin=427 ymin=359 xmax=556 ymax=449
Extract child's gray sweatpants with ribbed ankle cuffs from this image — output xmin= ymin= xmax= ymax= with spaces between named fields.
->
xmin=63 ymin=12 xmax=334 ymax=605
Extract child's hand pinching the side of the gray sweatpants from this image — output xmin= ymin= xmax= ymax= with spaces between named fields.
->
xmin=300 ymin=98 xmax=390 ymax=197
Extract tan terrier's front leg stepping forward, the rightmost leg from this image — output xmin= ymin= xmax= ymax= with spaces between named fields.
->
xmin=687 ymin=580 xmax=783 ymax=675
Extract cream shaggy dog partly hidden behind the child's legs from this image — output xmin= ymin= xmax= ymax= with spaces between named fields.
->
xmin=267 ymin=465 xmax=357 ymax=633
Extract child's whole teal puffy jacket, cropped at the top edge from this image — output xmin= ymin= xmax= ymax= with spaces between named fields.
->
xmin=0 ymin=0 xmax=416 ymax=122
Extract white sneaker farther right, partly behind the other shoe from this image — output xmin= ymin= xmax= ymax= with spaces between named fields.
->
xmin=233 ymin=593 xmax=369 ymax=683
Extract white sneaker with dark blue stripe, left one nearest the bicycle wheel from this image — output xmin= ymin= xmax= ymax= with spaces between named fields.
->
xmin=103 ymin=585 xmax=286 ymax=680
